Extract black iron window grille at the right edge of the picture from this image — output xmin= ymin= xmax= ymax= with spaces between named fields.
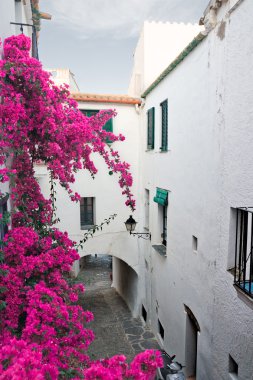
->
xmin=234 ymin=207 xmax=253 ymax=298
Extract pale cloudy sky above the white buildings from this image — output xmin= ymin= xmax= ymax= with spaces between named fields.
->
xmin=39 ymin=0 xmax=208 ymax=94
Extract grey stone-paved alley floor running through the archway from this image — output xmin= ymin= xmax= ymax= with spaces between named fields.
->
xmin=78 ymin=255 xmax=159 ymax=360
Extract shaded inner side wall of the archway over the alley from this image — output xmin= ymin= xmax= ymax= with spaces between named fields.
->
xmin=112 ymin=257 xmax=139 ymax=317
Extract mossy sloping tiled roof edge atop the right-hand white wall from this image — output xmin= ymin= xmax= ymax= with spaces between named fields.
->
xmin=141 ymin=32 xmax=207 ymax=98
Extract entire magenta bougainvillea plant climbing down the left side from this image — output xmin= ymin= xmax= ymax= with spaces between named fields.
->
xmin=0 ymin=35 xmax=162 ymax=380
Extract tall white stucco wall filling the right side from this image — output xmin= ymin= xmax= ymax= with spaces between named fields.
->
xmin=140 ymin=0 xmax=253 ymax=380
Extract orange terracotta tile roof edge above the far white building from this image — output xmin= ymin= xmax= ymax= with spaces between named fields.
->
xmin=71 ymin=92 xmax=141 ymax=105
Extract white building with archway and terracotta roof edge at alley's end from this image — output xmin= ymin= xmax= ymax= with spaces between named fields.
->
xmin=36 ymin=93 xmax=144 ymax=315
